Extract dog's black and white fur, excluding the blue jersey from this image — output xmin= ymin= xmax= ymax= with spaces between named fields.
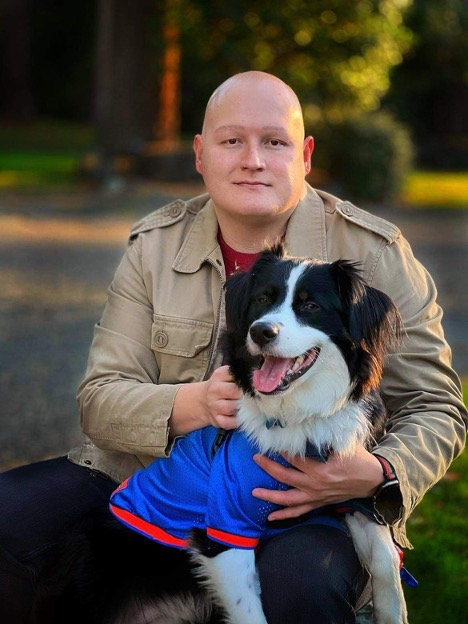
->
xmin=44 ymin=244 xmax=407 ymax=624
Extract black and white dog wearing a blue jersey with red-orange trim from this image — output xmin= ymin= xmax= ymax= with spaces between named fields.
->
xmin=105 ymin=243 xmax=407 ymax=624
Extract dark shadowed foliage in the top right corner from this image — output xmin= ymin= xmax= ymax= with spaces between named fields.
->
xmin=383 ymin=0 xmax=468 ymax=170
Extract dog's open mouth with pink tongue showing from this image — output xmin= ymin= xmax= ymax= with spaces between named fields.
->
xmin=252 ymin=347 xmax=320 ymax=394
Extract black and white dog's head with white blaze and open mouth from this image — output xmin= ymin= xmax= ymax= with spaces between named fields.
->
xmin=225 ymin=244 xmax=402 ymax=400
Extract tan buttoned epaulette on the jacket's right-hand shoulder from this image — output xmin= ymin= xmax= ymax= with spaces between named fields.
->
xmin=318 ymin=191 xmax=401 ymax=243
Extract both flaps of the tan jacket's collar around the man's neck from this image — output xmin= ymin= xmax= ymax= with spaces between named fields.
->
xmin=173 ymin=185 xmax=327 ymax=273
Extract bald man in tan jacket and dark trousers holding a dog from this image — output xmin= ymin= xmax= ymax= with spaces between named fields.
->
xmin=0 ymin=72 xmax=466 ymax=624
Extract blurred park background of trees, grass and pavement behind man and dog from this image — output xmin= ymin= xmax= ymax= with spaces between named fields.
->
xmin=0 ymin=0 xmax=468 ymax=624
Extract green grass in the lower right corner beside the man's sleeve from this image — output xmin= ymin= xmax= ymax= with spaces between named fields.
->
xmin=405 ymin=380 xmax=468 ymax=624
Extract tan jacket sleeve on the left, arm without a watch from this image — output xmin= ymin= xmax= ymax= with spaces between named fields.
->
xmin=77 ymin=238 xmax=180 ymax=456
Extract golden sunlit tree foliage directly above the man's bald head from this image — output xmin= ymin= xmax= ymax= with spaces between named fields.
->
xmin=181 ymin=0 xmax=411 ymax=129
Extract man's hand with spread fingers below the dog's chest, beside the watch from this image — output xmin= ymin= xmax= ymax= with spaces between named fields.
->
xmin=252 ymin=447 xmax=384 ymax=520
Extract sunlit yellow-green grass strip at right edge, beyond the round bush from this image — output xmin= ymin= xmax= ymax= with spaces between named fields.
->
xmin=401 ymin=171 xmax=468 ymax=208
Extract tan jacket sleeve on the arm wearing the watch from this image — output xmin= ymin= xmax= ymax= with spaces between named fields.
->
xmin=372 ymin=232 xmax=466 ymax=544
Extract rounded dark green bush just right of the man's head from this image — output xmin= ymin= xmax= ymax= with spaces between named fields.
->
xmin=314 ymin=112 xmax=413 ymax=201
